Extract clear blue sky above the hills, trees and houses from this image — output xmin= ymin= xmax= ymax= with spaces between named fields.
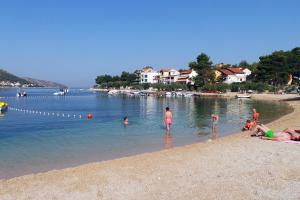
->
xmin=0 ymin=0 xmax=300 ymax=86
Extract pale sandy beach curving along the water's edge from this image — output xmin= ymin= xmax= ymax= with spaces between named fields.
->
xmin=0 ymin=95 xmax=300 ymax=200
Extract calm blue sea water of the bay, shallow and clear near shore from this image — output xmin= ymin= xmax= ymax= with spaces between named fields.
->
xmin=0 ymin=89 xmax=290 ymax=178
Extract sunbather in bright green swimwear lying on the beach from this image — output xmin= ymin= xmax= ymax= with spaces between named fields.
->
xmin=251 ymin=124 xmax=300 ymax=141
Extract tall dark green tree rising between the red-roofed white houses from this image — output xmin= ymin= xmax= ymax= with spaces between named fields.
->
xmin=189 ymin=53 xmax=215 ymax=86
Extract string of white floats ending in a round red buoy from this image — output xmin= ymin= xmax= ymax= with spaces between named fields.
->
xmin=8 ymin=106 xmax=93 ymax=119
